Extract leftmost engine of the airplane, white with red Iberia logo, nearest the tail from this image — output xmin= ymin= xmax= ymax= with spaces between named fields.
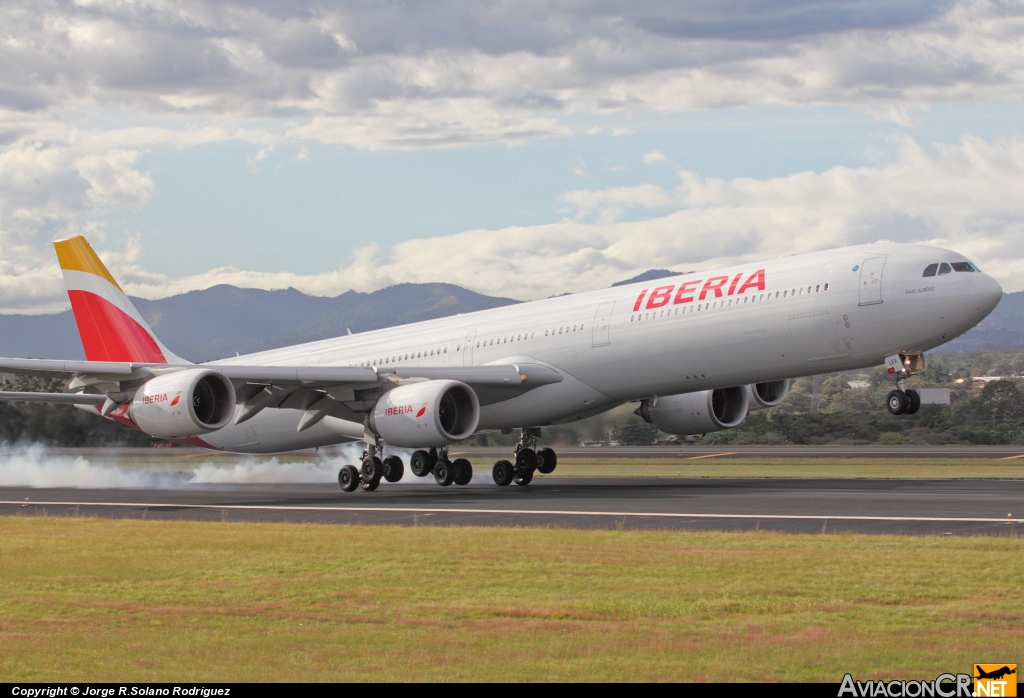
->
xmin=128 ymin=368 xmax=234 ymax=439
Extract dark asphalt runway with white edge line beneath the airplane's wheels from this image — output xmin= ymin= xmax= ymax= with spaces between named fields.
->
xmin=0 ymin=477 xmax=1024 ymax=535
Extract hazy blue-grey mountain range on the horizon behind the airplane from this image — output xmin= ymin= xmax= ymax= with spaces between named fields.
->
xmin=0 ymin=269 xmax=1024 ymax=361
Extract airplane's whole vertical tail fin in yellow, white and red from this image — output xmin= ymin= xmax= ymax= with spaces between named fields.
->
xmin=53 ymin=235 xmax=187 ymax=363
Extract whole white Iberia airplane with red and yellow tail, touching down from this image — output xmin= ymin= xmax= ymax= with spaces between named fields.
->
xmin=0 ymin=236 xmax=1002 ymax=491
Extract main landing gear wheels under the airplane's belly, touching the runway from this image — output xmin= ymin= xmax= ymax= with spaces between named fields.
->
xmin=338 ymin=427 xmax=558 ymax=492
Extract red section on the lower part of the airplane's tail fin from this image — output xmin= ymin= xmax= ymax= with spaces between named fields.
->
xmin=68 ymin=291 xmax=167 ymax=363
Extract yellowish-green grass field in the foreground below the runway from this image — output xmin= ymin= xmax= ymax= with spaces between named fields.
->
xmin=0 ymin=517 xmax=1024 ymax=682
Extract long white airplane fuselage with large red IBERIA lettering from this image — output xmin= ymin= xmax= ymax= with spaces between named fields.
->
xmin=190 ymin=244 xmax=1001 ymax=452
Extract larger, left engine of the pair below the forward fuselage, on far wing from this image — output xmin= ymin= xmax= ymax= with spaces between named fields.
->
xmin=636 ymin=386 xmax=750 ymax=436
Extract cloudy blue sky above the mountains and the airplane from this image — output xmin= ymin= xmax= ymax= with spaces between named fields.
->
xmin=0 ymin=0 xmax=1024 ymax=313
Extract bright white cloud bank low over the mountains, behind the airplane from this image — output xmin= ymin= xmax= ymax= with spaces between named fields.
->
xmin=0 ymin=137 xmax=1024 ymax=313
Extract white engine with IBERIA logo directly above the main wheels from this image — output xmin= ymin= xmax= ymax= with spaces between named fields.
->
xmin=370 ymin=381 xmax=480 ymax=448
